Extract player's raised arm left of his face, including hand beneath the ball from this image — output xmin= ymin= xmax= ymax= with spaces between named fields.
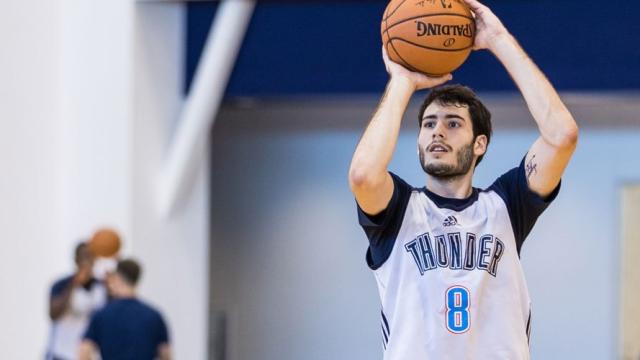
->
xmin=349 ymin=49 xmax=451 ymax=215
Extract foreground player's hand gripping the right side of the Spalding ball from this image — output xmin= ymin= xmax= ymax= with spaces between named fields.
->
xmin=464 ymin=0 xmax=509 ymax=50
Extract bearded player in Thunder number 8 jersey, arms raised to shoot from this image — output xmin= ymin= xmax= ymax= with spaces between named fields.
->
xmin=349 ymin=0 xmax=578 ymax=360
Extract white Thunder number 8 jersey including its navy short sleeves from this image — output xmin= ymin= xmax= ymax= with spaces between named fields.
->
xmin=359 ymin=163 xmax=559 ymax=360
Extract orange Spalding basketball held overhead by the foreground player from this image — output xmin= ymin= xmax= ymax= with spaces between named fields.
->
xmin=381 ymin=0 xmax=475 ymax=76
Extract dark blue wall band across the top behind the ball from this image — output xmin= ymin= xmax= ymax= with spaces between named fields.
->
xmin=186 ymin=0 xmax=640 ymax=96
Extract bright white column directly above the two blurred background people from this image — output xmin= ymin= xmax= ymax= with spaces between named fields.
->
xmin=59 ymin=0 xmax=134 ymax=253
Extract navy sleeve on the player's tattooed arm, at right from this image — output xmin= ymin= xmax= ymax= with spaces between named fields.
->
xmin=486 ymin=156 xmax=560 ymax=255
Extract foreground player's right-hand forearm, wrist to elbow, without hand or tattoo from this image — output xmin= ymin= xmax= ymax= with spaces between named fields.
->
xmin=491 ymin=34 xmax=578 ymax=147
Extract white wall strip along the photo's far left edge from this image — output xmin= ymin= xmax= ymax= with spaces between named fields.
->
xmin=0 ymin=0 xmax=63 ymax=359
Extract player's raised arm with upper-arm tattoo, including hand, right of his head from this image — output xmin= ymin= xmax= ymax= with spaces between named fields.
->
xmin=465 ymin=0 xmax=578 ymax=196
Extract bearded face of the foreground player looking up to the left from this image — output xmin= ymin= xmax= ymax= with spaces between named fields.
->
xmin=418 ymin=102 xmax=476 ymax=178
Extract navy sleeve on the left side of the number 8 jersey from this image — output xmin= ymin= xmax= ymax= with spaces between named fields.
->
xmin=358 ymin=172 xmax=413 ymax=270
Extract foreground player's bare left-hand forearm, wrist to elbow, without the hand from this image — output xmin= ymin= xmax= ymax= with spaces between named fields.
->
xmin=349 ymin=77 xmax=415 ymax=186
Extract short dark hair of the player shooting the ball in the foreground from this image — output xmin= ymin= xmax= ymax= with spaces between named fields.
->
xmin=418 ymin=84 xmax=491 ymax=166
